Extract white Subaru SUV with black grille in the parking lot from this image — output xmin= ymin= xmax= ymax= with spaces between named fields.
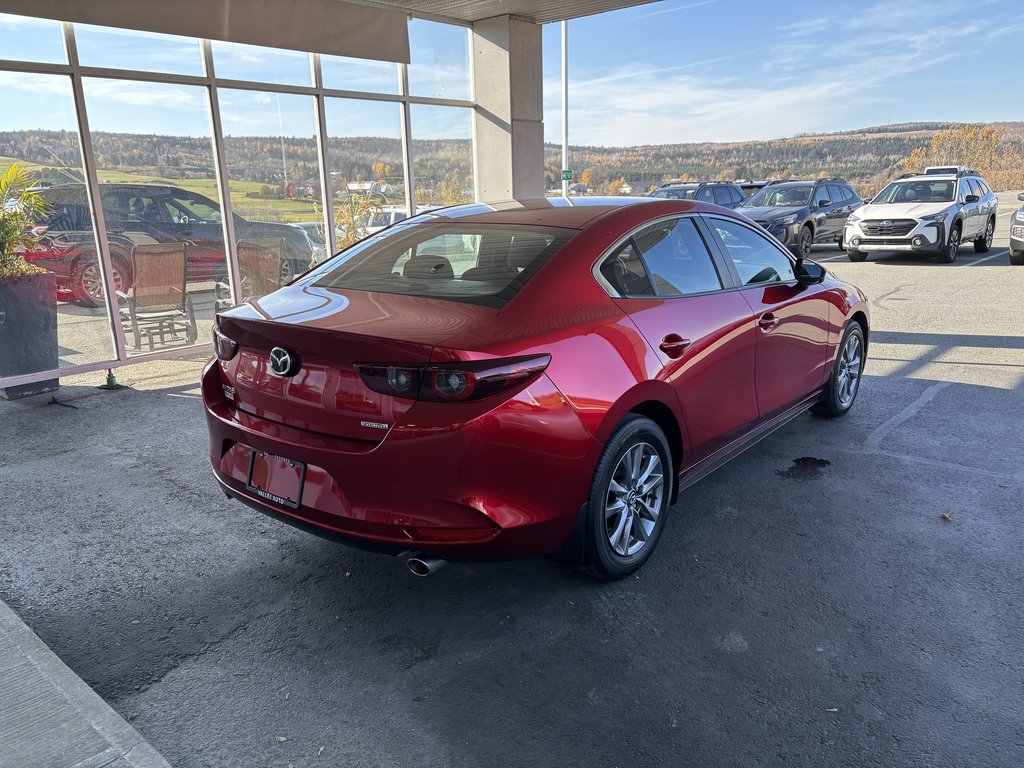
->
xmin=843 ymin=166 xmax=998 ymax=261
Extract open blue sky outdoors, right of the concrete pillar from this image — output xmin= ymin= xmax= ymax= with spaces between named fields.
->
xmin=544 ymin=0 xmax=1024 ymax=146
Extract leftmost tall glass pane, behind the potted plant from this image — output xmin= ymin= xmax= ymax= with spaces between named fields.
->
xmin=0 ymin=72 xmax=115 ymax=385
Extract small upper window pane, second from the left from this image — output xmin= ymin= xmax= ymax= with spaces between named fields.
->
xmin=75 ymin=24 xmax=203 ymax=76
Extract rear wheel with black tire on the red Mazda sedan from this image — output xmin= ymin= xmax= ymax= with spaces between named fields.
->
xmin=584 ymin=415 xmax=675 ymax=581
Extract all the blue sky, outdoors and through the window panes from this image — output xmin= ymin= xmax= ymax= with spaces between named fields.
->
xmin=0 ymin=0 xmax=1024 ymax=146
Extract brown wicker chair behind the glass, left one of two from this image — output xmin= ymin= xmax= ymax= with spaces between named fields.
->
xmin=118 ymin=243 xmax=199 ymax=351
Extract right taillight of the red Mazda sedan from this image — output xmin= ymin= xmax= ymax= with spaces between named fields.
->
xmin=355 ymin=354 xmax=551 ymax=402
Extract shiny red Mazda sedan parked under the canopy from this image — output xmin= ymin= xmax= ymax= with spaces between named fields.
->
xmin=203 ymin=198 xmax=868 ymax=579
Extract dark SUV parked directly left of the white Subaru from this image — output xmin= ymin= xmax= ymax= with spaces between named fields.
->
xmin=736 ymin=178 xmax=864 ymax=257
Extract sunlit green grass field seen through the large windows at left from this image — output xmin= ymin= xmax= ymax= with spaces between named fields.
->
xmin=0 ymin=157 xmax=322 ymax=222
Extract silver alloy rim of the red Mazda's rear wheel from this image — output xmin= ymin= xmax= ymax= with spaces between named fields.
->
xmin=604 ymin=442 xmax=665 ymax=557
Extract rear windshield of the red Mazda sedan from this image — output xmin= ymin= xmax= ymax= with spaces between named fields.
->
xmin=313 ymin=223 xmax=577 ymax=309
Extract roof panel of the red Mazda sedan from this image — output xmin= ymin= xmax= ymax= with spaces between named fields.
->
xmin=402 ymin=197 xmax=712 ymax=229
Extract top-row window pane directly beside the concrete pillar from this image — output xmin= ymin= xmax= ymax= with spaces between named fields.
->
xmin=409 ymin=18 xmax=469 ymax=98
